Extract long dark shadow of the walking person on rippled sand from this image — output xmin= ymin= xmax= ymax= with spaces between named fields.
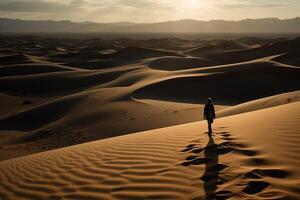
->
xmin=201 ymin=136 xmax=219 ymax=200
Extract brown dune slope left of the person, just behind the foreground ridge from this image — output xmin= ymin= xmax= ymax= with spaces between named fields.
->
xmin=0 ymin=84 xmax=225 ymax=158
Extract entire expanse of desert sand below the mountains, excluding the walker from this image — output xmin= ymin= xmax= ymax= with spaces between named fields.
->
xmin=0 ymin=36 xmax=300 ymax=200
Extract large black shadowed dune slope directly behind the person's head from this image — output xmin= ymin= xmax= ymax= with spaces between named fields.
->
xmin=133 ymin=62 xmax=300 ymax=105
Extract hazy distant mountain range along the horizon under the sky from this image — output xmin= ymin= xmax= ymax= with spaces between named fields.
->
xmin=0 ymin=17 xmax=300 ymax=33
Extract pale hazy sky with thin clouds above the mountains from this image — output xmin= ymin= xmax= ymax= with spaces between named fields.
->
xmin=0 ymin=0 xmax=300 ymax=22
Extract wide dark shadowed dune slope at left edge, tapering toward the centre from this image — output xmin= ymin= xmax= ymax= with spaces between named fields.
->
xmin=0 ymin=69 xmax=135 ymax=96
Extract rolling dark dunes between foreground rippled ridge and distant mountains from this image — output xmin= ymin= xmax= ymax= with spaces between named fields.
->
xmin=0 ymin=36 xmax=300 ymax=167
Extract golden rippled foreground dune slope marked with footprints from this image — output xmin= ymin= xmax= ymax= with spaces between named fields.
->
xmin=0 ymin=102 xmax=300 ymax=200
